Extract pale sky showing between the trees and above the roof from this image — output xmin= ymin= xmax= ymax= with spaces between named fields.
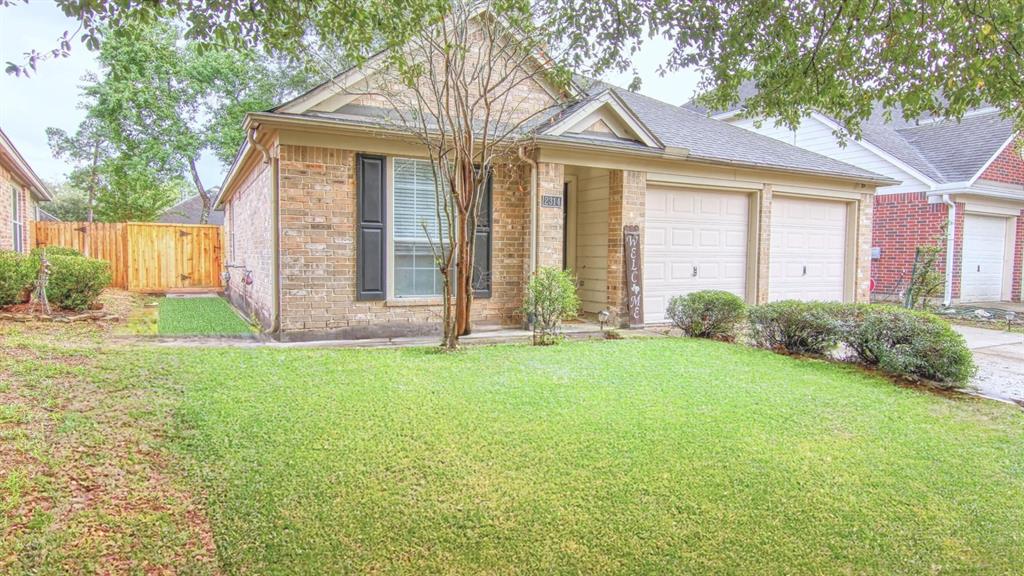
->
xmin=0 ymin=0 xmax=698 ymax=187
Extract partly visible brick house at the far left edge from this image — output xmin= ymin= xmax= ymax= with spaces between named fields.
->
xmin=0 ymin=130 xmax=52 ymax=252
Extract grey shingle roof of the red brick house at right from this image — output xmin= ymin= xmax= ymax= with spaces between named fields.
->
xmin=682 ymin=81 xmax=1014 ymax=184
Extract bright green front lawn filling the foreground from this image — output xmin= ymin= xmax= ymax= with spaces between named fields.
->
xmin=148 ymin=339 xmax=1024 ymax=574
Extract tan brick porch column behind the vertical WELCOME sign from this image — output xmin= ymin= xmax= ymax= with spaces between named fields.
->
xmin=608 ymin=170 xmax=647 ymax=324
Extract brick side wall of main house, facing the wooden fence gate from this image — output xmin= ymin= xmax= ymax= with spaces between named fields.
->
xmin=224 ymin=151 xmax=273 ymax=330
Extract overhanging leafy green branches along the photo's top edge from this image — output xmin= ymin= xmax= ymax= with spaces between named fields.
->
xmin=5 ymin=0 xmax=1024 ymax=131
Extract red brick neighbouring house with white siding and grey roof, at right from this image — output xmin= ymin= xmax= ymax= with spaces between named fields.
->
xmin=700 ymin=83 xmax=1024 ymax=303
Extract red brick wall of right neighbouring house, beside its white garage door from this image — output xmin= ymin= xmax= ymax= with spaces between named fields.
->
xmin=871 ymin=192 xmax=964 ymax=298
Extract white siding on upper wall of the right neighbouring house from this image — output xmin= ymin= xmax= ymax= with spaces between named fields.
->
xmin=731 ymin=117 xmax=928 ymax=194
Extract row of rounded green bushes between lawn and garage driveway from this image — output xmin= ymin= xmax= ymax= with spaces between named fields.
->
xmin=668 ymin=290 xmax=975 ymax=387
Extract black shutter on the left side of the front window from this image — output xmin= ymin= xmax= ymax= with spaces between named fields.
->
xmin=355 ymin=154 xmax=387 ymax=300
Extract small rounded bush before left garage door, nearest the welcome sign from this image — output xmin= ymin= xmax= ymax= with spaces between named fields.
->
xmin=667 ymin=290 xmax=746 ymax=340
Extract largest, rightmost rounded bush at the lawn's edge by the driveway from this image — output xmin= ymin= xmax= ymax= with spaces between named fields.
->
xmin=844 ymin=305 xmax=975 ymax=387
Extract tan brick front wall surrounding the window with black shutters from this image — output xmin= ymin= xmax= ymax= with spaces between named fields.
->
xmin=272 ymin=146 xmax=528 ymax=339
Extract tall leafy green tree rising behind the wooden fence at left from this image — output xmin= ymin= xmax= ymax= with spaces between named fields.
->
xmin=70 ymin=23 xmax=315 ymax=222
